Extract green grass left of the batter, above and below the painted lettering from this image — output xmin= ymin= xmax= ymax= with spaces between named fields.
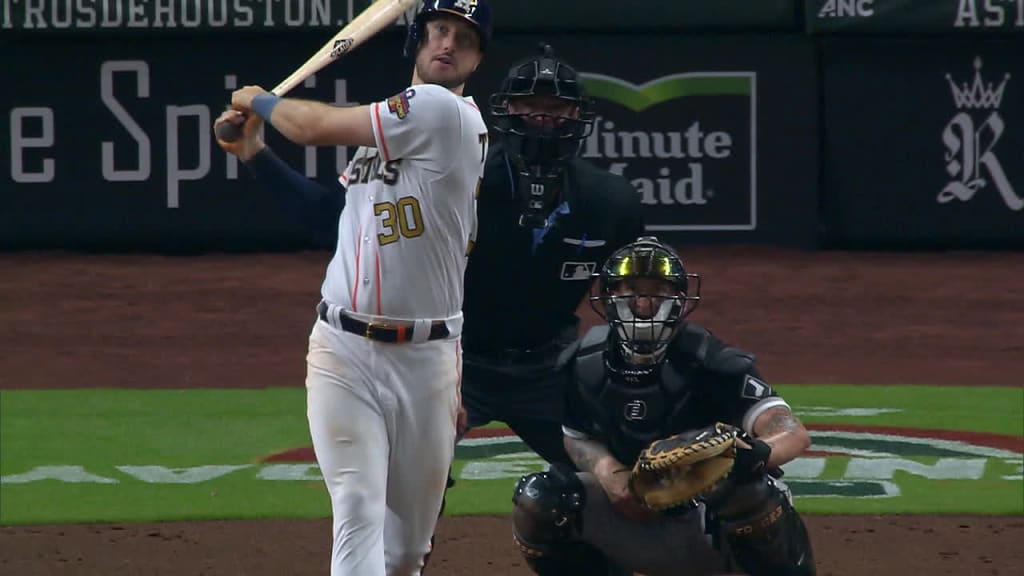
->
xmin=0 ymin=388 xmax=330 ymax=524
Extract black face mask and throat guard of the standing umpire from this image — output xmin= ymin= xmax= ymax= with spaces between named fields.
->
xmin=489 ymin=43 xmax=594 ymax=228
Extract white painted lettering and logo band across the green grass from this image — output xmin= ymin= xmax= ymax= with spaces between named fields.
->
xmin=0 ymin=424 xmax=1024 ymax=504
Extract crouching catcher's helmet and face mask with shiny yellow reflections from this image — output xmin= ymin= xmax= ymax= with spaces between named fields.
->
xmin=590 ymin=236 xmax=700 ymax=365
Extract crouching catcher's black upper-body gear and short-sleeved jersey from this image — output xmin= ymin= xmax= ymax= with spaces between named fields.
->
xmin=564 ymin=323 xmax=788 ymax=467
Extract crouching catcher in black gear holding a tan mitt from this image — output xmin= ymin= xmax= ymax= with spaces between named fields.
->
xmin=513 ymin=237 xmax=815 ymax=576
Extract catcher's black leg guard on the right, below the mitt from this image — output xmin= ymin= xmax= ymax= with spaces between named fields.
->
xmin=713 ymin=477 xmax=815 ymax=576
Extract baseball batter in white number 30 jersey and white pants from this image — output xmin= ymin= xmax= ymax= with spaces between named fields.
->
xmin=218 ymin=0 xmax=490 ymax=576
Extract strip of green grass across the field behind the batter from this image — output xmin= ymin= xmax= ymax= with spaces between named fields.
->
xmin=0 ymin=386 xmax=1024 ymax=525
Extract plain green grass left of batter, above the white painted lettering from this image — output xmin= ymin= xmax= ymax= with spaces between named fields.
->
xmin=0 ymin=388 xmax=309 ymax=467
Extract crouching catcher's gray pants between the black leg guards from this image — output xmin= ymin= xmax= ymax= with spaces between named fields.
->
xmin=577 ymin=472 xmax=734 ymax=576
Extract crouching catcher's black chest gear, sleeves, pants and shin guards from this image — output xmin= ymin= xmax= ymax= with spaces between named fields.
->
xmin=513 ymin=323 xmax=814 ymax=576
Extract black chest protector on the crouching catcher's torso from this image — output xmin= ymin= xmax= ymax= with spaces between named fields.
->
xmin=577 ymin=351 xmax=689 ymax=465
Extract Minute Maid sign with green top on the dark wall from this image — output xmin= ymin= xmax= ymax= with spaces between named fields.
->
xmin=580 ymin=72 xmax=757 ymax=232
